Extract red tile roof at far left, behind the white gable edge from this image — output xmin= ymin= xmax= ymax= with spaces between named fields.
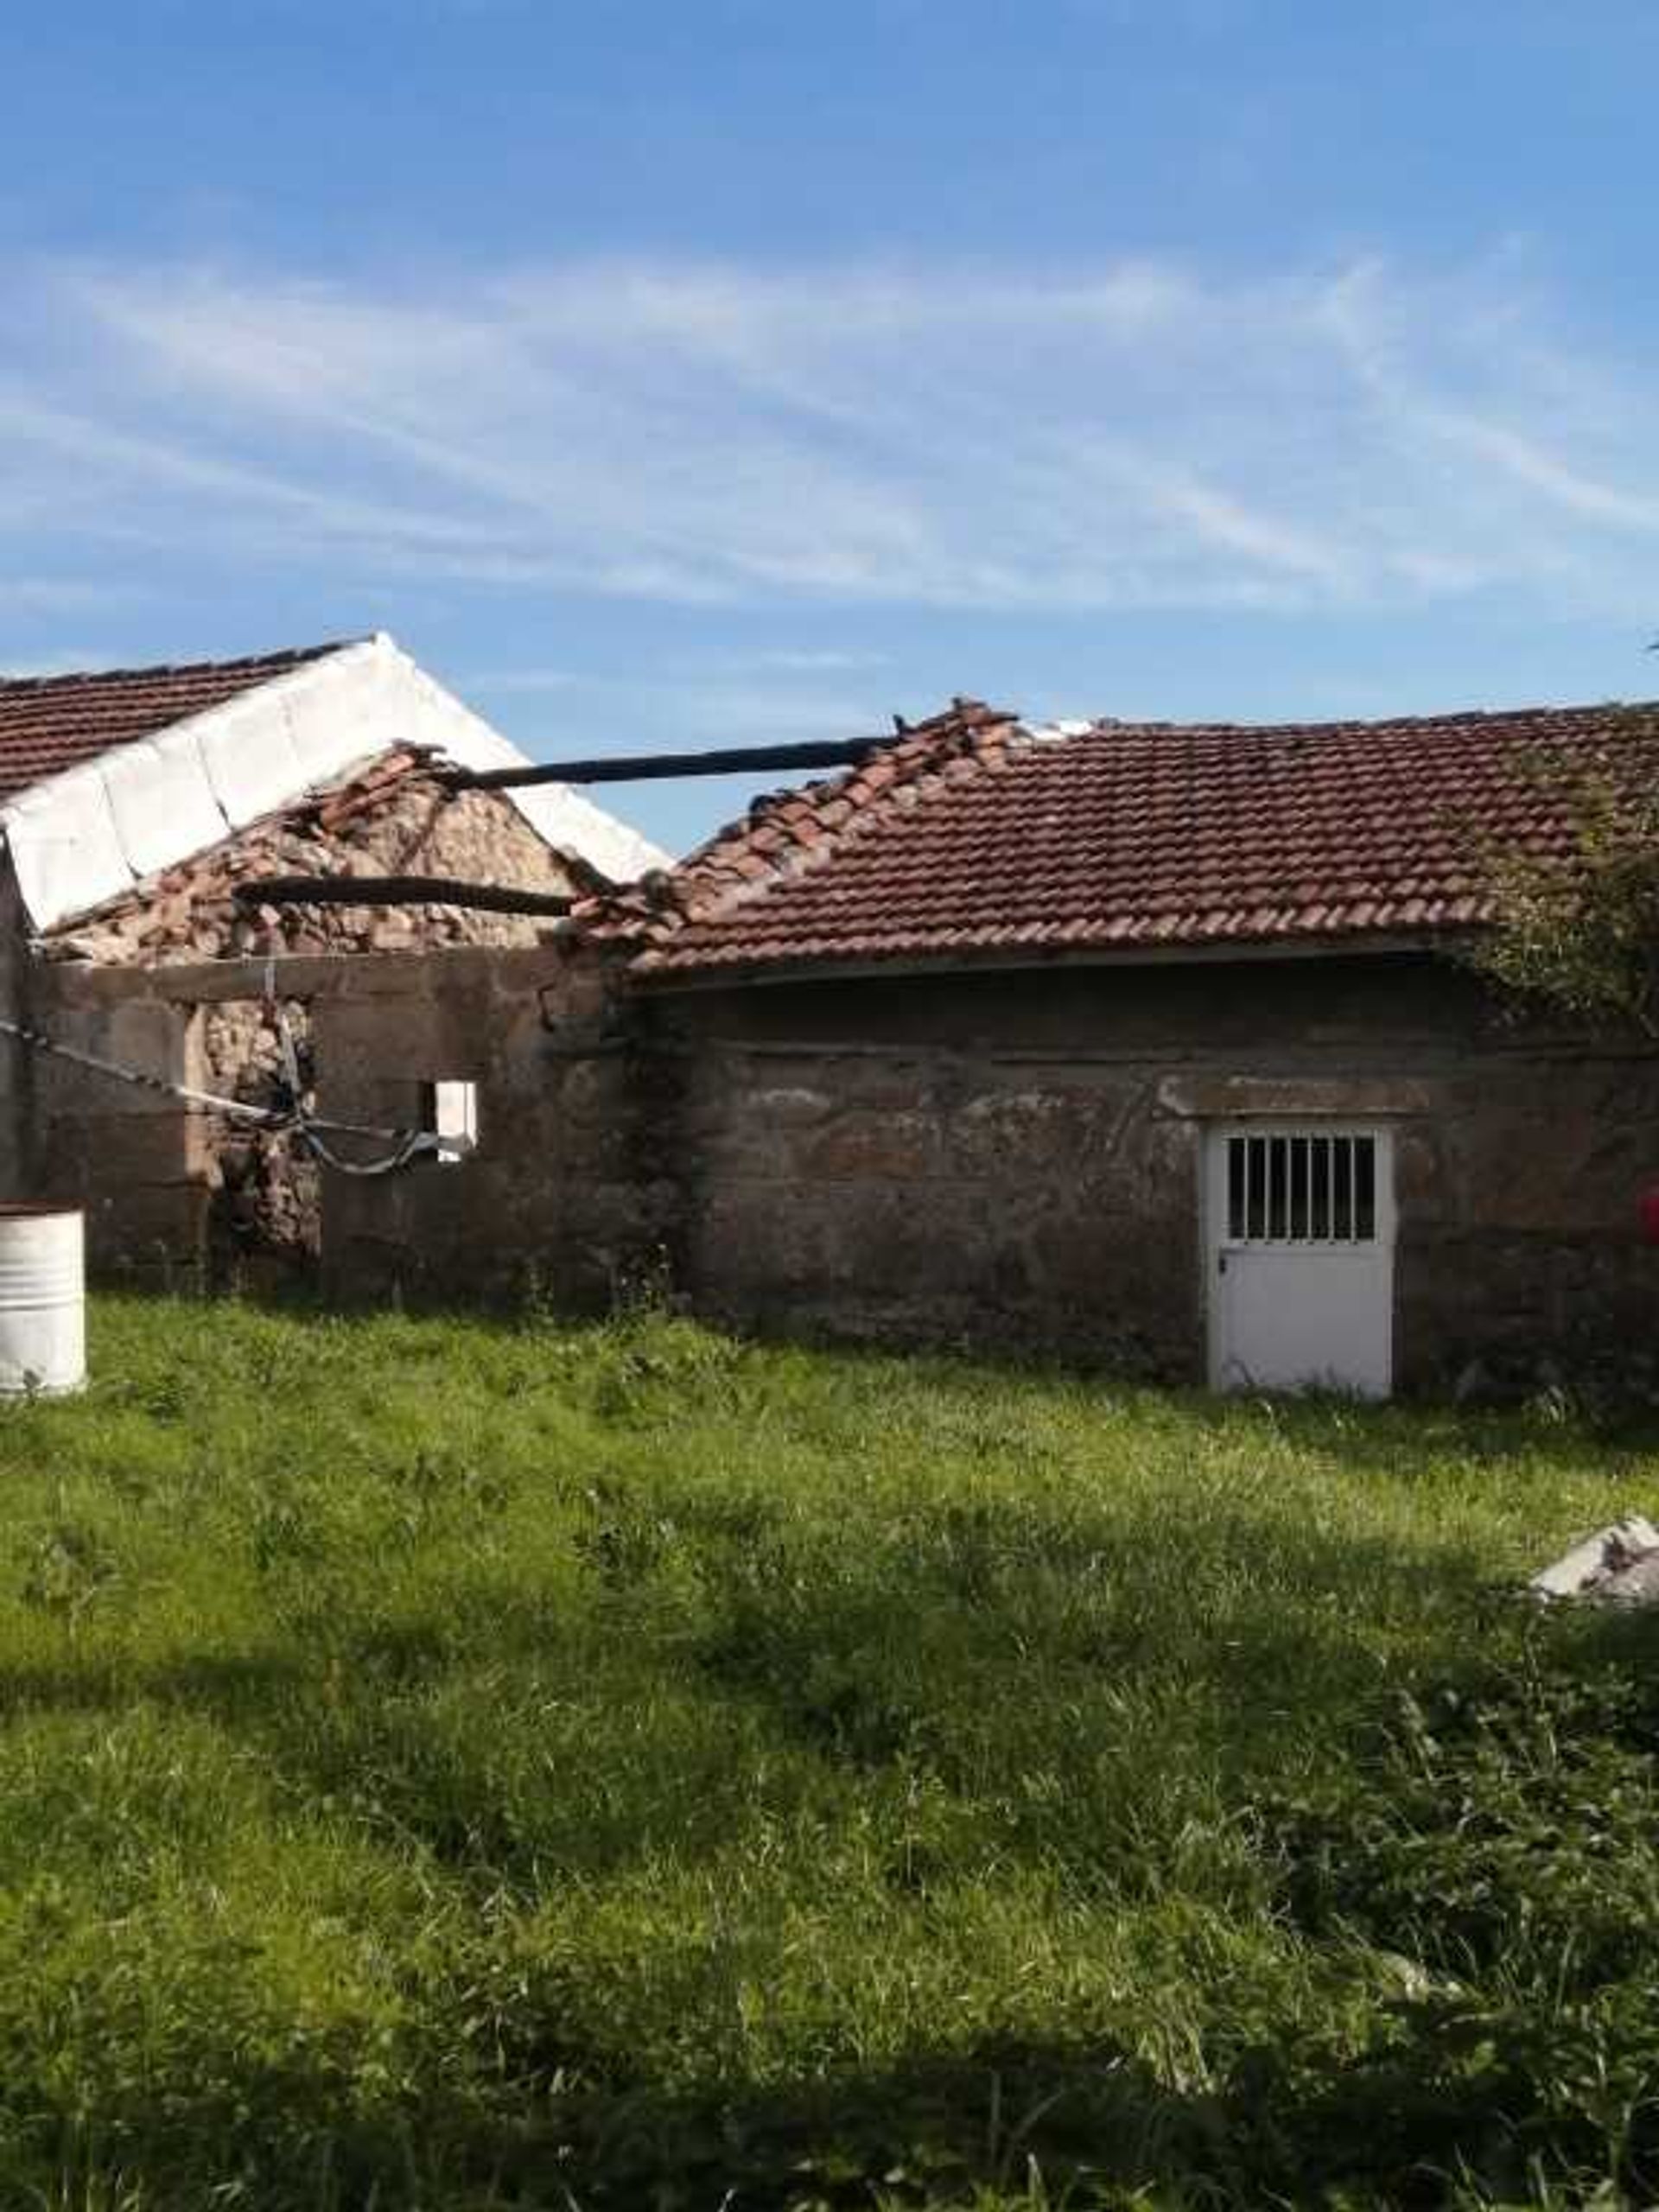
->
xmin=0 ymin=641 xmax=358 ymax=801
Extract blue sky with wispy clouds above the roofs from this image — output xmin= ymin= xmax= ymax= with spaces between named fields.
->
xmin=0 ymin=0 xmax=1659 ymax=849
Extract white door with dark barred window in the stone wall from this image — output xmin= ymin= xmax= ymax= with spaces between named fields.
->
xmin=1205 ymin=1122 xmax=1394 ymax=1398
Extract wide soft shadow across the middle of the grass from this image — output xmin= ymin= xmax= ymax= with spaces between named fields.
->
xmin=0 ymin=1491 xmax=1520 ymax=1889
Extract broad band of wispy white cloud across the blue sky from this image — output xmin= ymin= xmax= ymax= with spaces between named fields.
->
xmin=0 ymin=257 xmax=1659 ymax=623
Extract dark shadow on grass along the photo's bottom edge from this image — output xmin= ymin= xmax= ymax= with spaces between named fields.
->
xmin=0 ymin=1583 xmax=1659 ymax=2212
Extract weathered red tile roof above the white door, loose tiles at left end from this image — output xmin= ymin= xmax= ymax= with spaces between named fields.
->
xmin=635 ymin=702 xmax=1659 ymax=976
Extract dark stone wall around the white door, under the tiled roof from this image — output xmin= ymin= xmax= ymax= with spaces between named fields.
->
xmin=632 ymin=956 xmax=1659 ymax=1387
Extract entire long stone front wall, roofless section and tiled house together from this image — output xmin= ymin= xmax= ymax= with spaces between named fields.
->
xmin=13 ymin=940 xmax=1659 ymax=1389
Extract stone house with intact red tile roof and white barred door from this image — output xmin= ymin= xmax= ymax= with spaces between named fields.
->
xmin=597 ymin=702 xmax=1659 ymax=1394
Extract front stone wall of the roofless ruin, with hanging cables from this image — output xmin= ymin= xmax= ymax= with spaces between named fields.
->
xmin=27 ymin=943 xmax=672 ymax=1310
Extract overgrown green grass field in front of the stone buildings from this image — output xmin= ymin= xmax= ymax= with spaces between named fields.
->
xmin=0 ymin=1300 xmax=1659 ymax=2212
